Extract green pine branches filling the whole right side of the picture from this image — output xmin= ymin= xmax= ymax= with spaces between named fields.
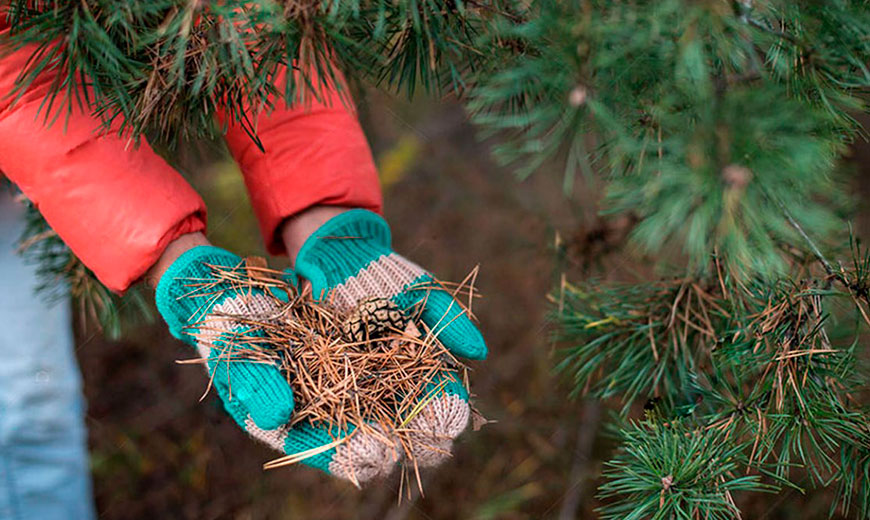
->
xmin=476 ymin=0 xmax=870 ymax=519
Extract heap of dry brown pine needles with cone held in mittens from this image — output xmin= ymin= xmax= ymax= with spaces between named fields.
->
xmin=185 ymin=257 xmax=477 ymax=484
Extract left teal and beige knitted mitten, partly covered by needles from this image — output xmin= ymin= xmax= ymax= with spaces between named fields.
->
xmin=156 ymin=246 xmax=398 ymax=483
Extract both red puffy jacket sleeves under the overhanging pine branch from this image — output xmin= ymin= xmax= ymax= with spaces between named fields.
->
xmin=0 ymin=17 xmax=381 ymax=292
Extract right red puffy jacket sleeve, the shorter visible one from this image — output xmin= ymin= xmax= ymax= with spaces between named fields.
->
xmin=221 ymin=68 xmax=382 ymax=254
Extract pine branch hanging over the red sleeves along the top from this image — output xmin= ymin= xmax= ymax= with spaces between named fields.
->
xmin=2 ymin=0 xmax=497 ymax=143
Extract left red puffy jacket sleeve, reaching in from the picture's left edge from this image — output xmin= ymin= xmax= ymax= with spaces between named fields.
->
xmin=0 ymin=25 xmax=205 ymax=291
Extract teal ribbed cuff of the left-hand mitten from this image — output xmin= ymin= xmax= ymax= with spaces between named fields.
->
xmin=155 ymin=246 xmax=242 ymax=342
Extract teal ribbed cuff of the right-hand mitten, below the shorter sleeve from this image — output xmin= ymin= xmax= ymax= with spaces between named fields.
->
xmin=296 ymin=209 xmax=392 ymax=298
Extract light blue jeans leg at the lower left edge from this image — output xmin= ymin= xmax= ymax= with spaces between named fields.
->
xmin=0 ymin=192 xmax=94 ymax=520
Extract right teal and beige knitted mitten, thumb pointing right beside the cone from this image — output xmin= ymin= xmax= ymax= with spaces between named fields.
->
xmin=296 ymin=209 xmax=487 ymax=469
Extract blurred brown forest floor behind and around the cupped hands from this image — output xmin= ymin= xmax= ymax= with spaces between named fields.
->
xmin=77 ymin=90 xmax=870 ymax=520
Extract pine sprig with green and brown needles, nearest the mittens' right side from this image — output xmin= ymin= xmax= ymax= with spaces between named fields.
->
xmin=558 ymin=281 xmax=702 ymax=411
